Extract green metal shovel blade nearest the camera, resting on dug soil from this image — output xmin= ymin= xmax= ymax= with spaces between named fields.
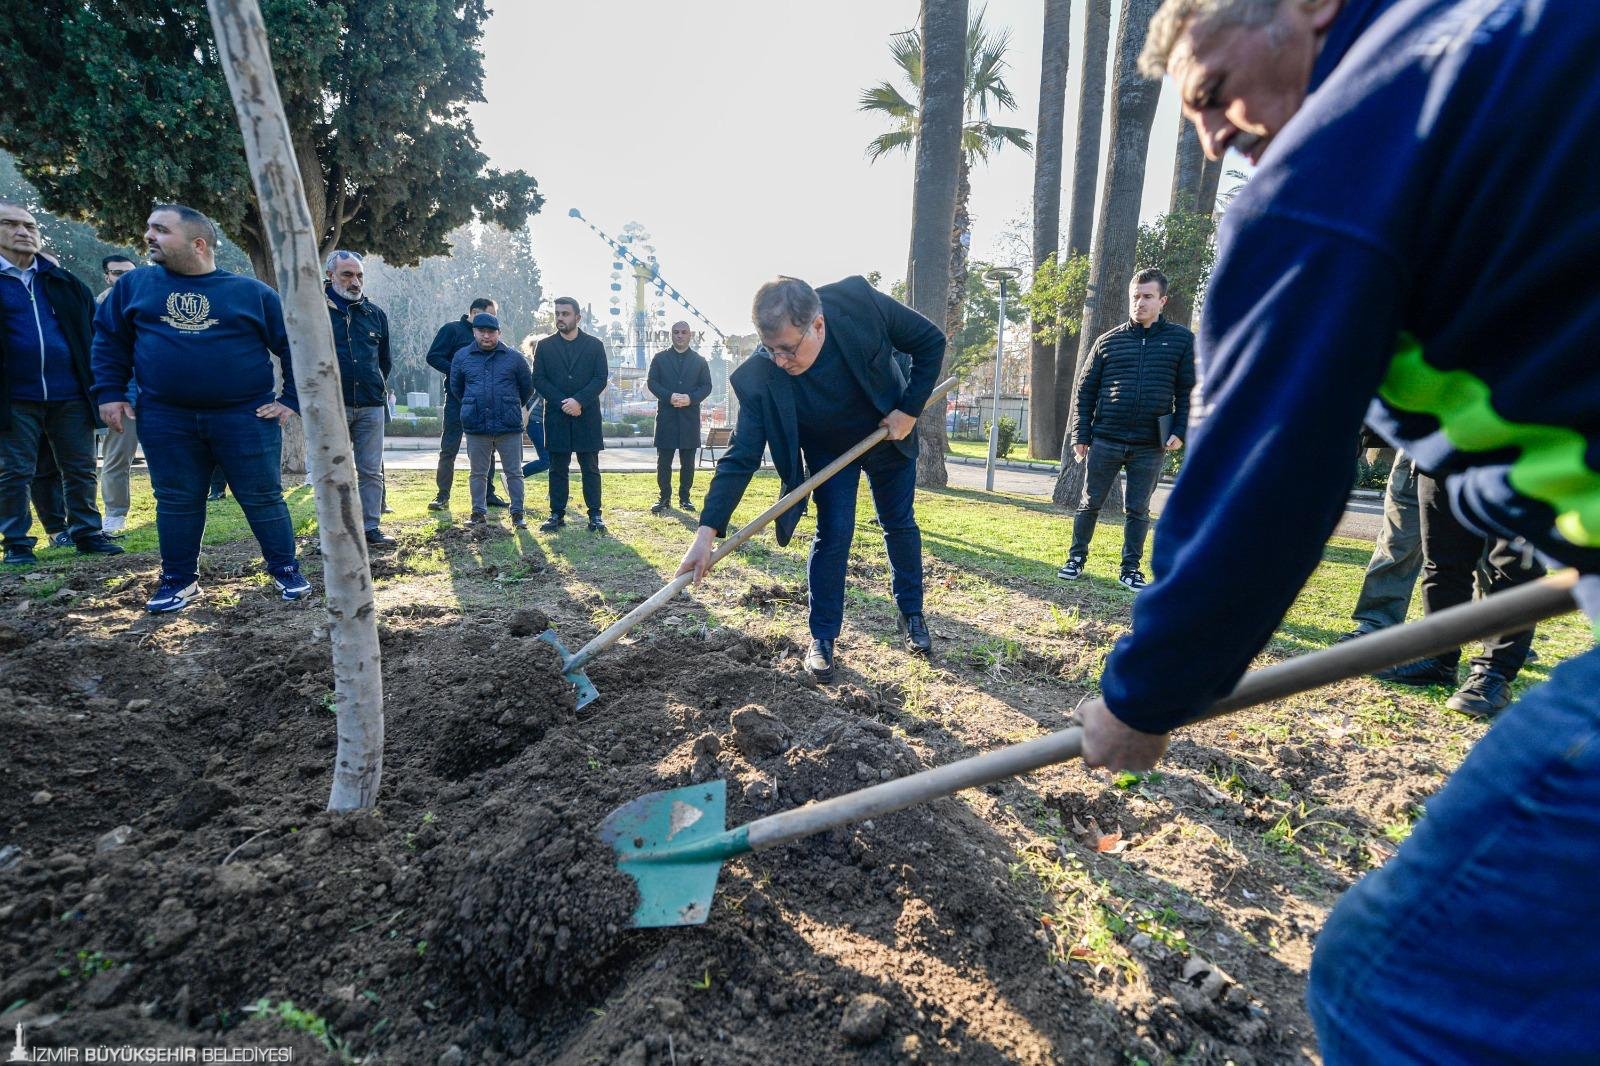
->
xmin=600 ymin=779 xmax=732 ymax=928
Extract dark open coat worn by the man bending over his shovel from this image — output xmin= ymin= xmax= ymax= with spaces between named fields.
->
xmin=701 ymin=277 xmax=944 ymax=544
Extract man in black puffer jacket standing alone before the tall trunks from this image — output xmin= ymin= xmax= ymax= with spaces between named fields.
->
xmin=1056 ymin=267 xmax=1195 ymax=592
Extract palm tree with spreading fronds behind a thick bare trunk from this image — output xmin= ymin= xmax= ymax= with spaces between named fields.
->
xmin=861 ymin=8 xmax=1032 ymax=335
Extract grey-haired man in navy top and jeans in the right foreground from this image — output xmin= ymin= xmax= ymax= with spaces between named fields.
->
xmin=1082 ymin=0 xmax=1600 ymax=1063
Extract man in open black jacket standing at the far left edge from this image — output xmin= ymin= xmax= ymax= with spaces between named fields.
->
xmin=0 ymin=200 xmax=122 ymax=567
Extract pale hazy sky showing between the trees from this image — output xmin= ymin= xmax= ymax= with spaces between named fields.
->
xmin=474 ymin=0 xmax=1216 ymax=333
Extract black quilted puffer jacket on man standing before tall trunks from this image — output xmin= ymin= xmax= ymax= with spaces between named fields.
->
xmin=1072 ymin=319 xmax=1195 ymax=445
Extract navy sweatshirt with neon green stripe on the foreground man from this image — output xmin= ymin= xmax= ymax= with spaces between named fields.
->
xmin=1101 ymin=0 xmax=1600 ymax=733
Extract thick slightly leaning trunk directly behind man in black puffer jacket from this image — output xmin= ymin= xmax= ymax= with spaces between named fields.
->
xmin=1053 ymin=0 xmax=1162 ymax=507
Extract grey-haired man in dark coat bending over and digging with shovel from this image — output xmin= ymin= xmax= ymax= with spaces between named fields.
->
xmin=678 ymin=277 xmax=944 ymax=682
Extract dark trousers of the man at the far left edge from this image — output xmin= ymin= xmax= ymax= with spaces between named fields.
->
xmin=0 ymin=400 xmax=101 ymax=549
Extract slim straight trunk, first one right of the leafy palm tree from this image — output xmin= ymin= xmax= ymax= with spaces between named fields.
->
xmin=1027 ymin=0 xmax=1072 ymax=459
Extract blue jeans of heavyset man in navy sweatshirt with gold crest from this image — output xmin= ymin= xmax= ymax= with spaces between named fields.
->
xmin=139 ymin=402 xmax=294 ymax=579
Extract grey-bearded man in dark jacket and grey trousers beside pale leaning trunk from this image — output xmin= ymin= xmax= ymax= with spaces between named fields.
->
xmin=323 ymin=251 xmax=395 ymax=547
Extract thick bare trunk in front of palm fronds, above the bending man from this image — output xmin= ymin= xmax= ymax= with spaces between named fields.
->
xmin=906 ymin=0 xmax=966 ymax=488
